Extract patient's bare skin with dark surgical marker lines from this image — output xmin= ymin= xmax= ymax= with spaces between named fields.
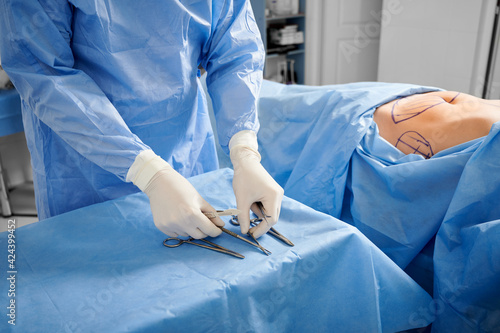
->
xmin=373 ymin=91 xmax=500 ymax=158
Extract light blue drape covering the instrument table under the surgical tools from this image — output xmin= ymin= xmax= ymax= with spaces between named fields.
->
xmin=0 ymin=169 xmax=431 ymax=332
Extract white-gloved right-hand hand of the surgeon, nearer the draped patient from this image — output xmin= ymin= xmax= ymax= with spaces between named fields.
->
xmin=229 ymin=131 xmax=283 ymax=238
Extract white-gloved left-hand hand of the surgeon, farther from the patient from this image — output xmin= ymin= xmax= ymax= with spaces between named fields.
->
xmin=127 ymin=150 xmax=224 ymax=239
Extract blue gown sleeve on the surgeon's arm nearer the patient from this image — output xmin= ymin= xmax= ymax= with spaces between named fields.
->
xmin=201 ymin=0 xmax=265 ymax=153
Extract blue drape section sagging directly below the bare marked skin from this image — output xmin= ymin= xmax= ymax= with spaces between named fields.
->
xmin=341 ymin=123 xmax=482 ymax=267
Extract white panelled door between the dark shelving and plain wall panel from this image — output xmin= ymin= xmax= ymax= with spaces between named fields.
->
xmin=305 ymin=0 xmax=382 ymax=85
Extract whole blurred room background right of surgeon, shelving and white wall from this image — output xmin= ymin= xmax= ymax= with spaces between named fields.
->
xmin=251 ymin=0 xmax=500 ymax=99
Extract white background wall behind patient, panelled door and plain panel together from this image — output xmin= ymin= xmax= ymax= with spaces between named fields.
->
xmin=305 ymin=0 xmax=500 ymax=93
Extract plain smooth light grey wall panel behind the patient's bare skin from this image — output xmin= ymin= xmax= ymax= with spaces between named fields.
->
xmin=378 ymin=0 xmax=497 ymax=97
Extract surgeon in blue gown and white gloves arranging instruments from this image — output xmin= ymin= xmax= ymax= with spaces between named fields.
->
xmin=0 ymin=0 xmax=283 ymax=238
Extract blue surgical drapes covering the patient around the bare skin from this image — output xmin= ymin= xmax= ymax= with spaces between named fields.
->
xmin=259 ymin=82 xmax=500 ymax=332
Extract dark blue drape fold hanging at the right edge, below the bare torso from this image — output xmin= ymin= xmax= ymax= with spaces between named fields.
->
xmin=433 ymin=122 xmax=500 ymax=332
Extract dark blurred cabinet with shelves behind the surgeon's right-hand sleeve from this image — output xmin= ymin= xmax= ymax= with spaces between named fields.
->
xmin=250 ymin=0 xmax=307 ymax=84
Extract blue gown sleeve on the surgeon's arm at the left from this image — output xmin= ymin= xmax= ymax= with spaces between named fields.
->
xmin=0 ymin=0 xmax=149 ymax=180
